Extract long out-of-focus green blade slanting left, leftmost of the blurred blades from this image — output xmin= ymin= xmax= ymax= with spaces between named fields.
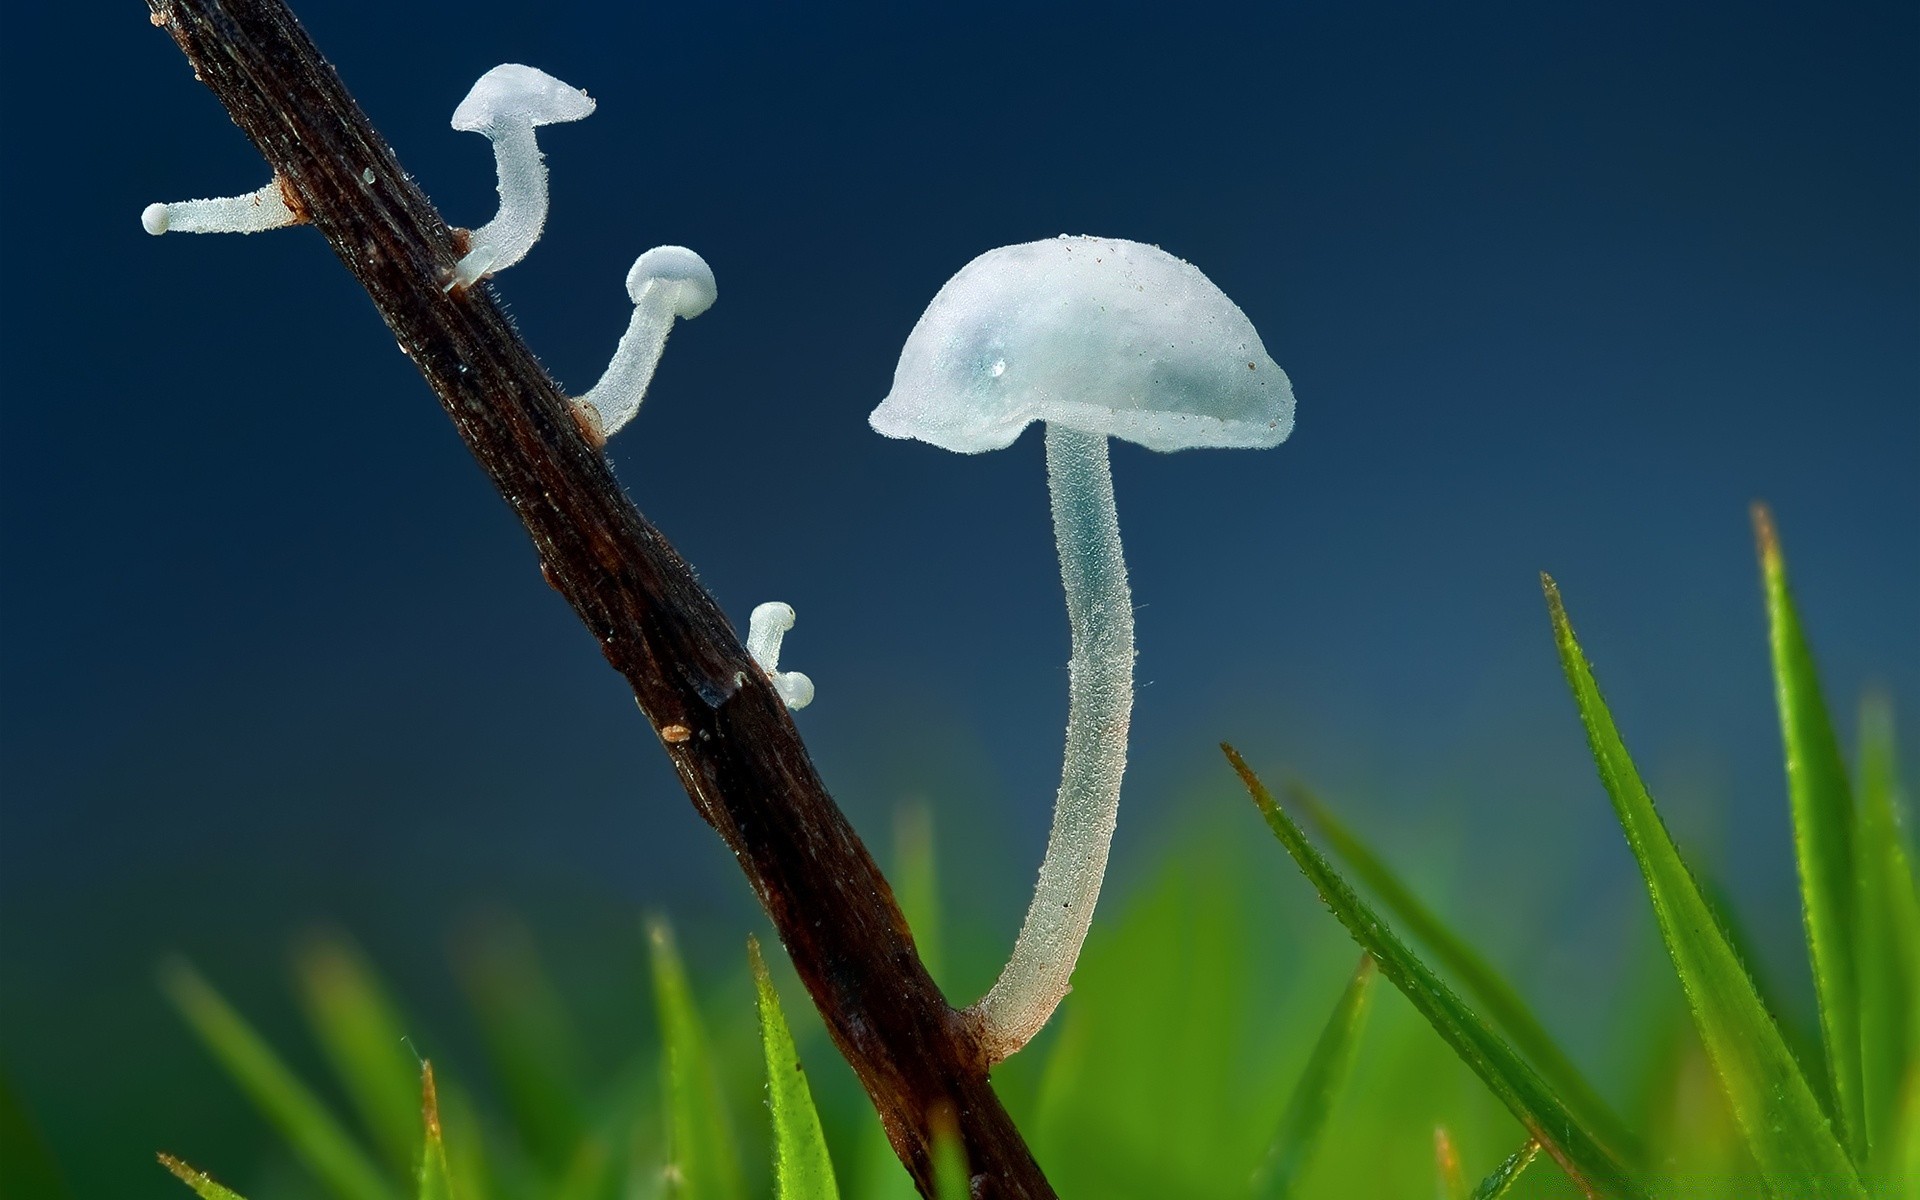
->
xmin=161 ymin=962 xmax=394 ymax=1200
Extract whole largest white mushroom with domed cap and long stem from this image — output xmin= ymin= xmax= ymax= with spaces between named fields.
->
xmin=868 ymin=236 xmax=1294 ymax=1062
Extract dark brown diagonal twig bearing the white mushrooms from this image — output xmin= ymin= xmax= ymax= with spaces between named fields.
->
xmin=150 ymin=0 xmax=1054 ymax=1198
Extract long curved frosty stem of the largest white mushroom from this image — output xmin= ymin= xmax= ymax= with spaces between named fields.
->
xmin=966 ymin=422 xmax=1133 ymax=1064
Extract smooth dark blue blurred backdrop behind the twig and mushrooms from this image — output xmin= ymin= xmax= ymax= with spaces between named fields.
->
xmin=0 ymin=0 xmax=1920 ymax=1188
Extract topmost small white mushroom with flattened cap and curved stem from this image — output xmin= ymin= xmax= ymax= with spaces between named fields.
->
xmin=449 ymin=63 xmax=593 ymax=290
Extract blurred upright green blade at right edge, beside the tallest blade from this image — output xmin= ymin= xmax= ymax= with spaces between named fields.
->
xmin=1853 ymin=697 xmax=1920 ymax=1175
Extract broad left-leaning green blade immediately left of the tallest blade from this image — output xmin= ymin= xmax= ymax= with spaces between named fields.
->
xmin=1530 ymin=576 xmax=1866 ymax=1198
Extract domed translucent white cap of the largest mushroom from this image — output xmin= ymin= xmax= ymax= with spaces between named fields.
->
xmin=868 ymin=234 xmax=1294 ymax=453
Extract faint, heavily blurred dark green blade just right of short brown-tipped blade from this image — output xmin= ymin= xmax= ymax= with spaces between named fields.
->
xmin=459 ymin=918 xmax=588 ymax=1177
